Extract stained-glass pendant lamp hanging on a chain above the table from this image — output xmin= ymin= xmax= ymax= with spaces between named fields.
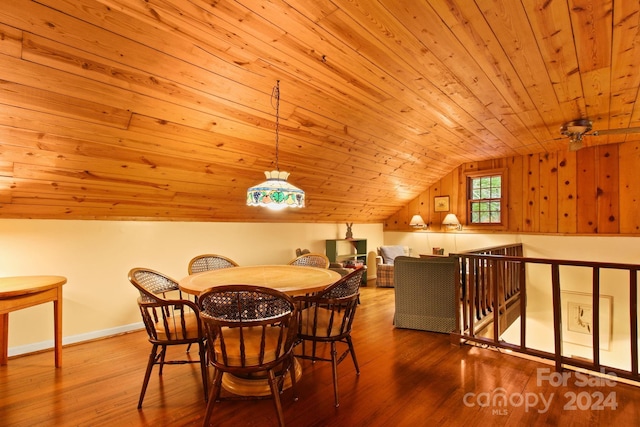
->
xmin=247 ymin=80 xmax=304 ymax=209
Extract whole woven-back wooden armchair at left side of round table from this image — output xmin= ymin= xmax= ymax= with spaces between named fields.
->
xmin=129 ymin=268 xmax=208 ymax=408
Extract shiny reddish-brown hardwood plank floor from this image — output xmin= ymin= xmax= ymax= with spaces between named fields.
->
xmin=0 ymin=288 xmax=640 ymax=427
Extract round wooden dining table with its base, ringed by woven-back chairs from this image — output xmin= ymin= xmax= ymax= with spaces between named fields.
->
xmin=178 ymin=265 xmax=342 ymax=396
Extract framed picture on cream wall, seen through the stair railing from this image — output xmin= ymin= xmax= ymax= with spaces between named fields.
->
xmin=561 ymin=291 xmax=613 ymax=350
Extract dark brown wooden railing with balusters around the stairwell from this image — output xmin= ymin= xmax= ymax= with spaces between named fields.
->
xmin=451 ymin=244 xmax=640 ymax=382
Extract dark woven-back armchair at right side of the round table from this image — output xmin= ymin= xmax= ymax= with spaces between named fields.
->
xmin=295 ymin=268 xmax=364 ymax=407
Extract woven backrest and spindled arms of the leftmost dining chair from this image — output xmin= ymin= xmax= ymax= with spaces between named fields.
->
xmin=129 ymin=268 xmax=203 ymax=344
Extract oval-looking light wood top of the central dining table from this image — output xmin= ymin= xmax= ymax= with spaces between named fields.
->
xmin=179 ymin=265 xmax=342 ymax=296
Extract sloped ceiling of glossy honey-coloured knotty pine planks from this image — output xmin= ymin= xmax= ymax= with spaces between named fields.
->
xmin=0 ymin=0 xmax=640 ymax=223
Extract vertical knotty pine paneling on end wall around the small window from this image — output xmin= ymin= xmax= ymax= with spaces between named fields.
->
xmin=385 ymin=141 xmax=640 ymax=235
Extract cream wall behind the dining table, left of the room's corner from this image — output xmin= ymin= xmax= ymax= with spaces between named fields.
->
xmin=0 ymin=220 xmax=383 ymax=355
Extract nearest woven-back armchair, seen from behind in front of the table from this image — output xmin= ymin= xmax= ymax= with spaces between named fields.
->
xmin=198 ymin=285 xmax=297 ymax=426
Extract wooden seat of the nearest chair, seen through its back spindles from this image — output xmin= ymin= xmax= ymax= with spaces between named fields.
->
xmin=215 ymin=326 xmax=284 ymax=366
